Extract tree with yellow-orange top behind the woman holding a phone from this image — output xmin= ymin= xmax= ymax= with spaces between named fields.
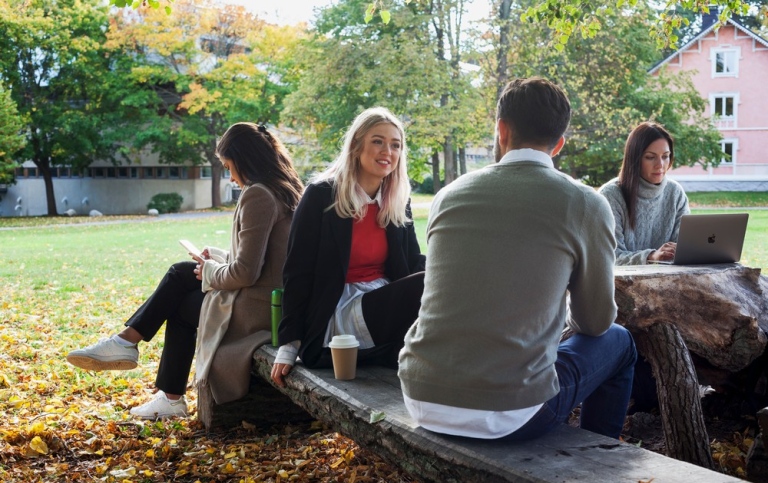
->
xmin=109 ymin=0 xmax=298 ymax=206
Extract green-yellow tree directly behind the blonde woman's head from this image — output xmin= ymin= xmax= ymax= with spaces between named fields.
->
xmin=284 ymin=0 xmax=480 ymax=191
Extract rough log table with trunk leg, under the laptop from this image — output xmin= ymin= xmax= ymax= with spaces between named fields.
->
xmin=615 ymin=263 xmax=768 ymax=468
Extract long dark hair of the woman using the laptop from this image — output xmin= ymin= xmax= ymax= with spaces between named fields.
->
xmin=619 ymin=121 xmax=675 ymax=230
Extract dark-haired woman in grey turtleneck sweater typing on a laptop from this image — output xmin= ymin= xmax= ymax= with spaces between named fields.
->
xmin=599 ymin=122 xmax=691 ymax=265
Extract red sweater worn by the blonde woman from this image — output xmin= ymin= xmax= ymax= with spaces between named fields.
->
xmin=346 ymin=203 xmax=388 ymax=283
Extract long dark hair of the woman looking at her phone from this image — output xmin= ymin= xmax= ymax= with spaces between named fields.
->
xmin=216 ymin=122 xmax=304 ymax=211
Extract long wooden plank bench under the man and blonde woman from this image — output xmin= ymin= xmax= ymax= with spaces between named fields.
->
xmin=228 ymin=346 xmax=742 ymax=483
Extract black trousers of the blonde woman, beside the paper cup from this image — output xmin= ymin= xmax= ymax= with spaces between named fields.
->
xmin=307 ymin=272 xmax=424 ymax=368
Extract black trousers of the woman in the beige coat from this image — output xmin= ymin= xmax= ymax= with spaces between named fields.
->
xmin=125 ymin=262 xmax=205 ymax=394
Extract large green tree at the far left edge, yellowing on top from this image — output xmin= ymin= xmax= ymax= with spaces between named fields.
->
xmin=0 ymin=0 xmax=140 ymax=215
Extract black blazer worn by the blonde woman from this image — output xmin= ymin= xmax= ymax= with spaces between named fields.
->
xmin=278 ymin=181 xmax=426 ymax=367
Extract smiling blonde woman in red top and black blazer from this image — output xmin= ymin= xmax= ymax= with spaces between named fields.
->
xmin=272 ymin=107 xmax=425 ymax=386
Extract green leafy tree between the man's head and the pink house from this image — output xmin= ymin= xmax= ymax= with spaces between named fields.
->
xmin=487 ymin=0 xmax=722 ymax=186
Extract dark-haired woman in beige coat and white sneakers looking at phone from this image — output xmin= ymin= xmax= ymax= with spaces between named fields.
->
xmin=67 ymin=123 xmax=304 ymax=419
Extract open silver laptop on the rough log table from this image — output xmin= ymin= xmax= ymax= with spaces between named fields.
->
xmin=656 ymin=213 xmax=749 ymax=265
